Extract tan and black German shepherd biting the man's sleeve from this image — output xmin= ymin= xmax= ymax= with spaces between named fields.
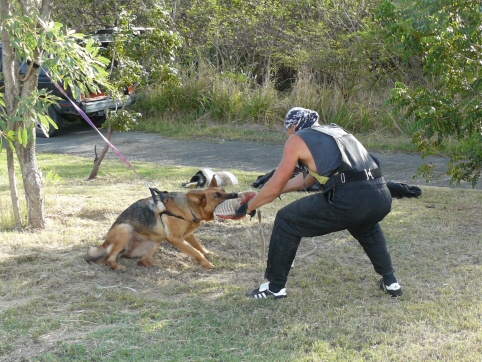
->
xmin=86 ymin=186 xmax=238 ymax=270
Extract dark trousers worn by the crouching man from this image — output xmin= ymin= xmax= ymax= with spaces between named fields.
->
xmin=265 ymin=177 xmax=393 ymax=286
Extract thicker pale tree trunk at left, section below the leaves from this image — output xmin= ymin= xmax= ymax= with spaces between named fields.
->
xmin=15 ymin=136 xmax=45 ymax=229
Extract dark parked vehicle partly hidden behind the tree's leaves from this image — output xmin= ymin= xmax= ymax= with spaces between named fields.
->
xmin=0 ymin=29 xmax=134 ymax=137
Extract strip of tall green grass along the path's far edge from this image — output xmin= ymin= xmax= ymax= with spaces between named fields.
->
xmin=135 ymin=61 xmax=405 ymax=140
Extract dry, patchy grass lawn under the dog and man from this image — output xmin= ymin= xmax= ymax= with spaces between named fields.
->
xmin=0 ymin=153 xmax=482 ymax=361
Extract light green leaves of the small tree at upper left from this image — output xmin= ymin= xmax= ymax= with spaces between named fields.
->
xmin=0 ymin=11 xmax=112 ymax=146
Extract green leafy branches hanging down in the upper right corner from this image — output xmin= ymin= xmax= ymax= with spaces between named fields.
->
xmin=378 ymin=0 xmax=482 ymax=185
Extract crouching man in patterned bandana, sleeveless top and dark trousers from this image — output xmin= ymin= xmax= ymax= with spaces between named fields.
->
xmin=236 ymin=107 xmax=402 ymax=299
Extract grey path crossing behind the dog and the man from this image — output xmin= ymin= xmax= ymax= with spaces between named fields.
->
xmin=37 ymin=128 xmax=482 ymax=189
